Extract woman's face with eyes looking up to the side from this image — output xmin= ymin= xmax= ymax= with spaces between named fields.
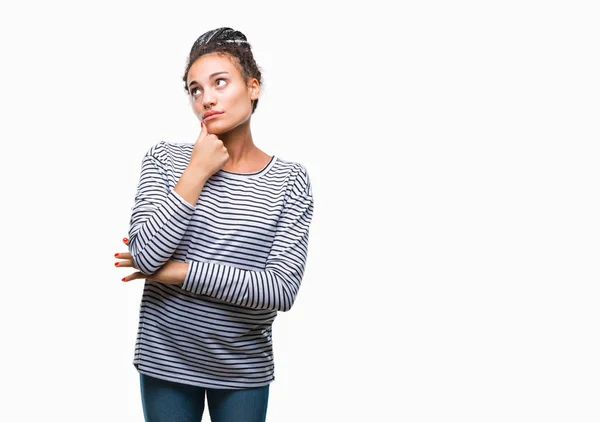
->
xmin=187 ymin=53 xmax=260 ymax=134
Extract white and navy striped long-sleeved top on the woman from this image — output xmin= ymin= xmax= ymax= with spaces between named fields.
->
xmin=129 ymin=141 xmax=313 ymax=389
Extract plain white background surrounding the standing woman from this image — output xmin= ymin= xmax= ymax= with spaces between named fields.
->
xmin=0 ymin=0 xmax=600 ymax=422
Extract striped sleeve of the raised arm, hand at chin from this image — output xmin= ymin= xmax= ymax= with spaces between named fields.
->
xmin=129 ymin=144 xmax=195 ymax=274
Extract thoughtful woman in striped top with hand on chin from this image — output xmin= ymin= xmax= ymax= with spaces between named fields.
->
xmin=115 ymin=28 xmax=313 ymax=422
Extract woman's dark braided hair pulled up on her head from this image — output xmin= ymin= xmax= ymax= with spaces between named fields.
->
xmin=183 ymin=27 xmax=263 ymax=114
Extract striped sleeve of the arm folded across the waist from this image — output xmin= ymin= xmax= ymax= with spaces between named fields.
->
xmin=181 ymin=164 xmax=313 ymax=312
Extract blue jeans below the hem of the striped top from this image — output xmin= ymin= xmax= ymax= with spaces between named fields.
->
xmin=140 ymin=373 xmax=269 ymax=422
